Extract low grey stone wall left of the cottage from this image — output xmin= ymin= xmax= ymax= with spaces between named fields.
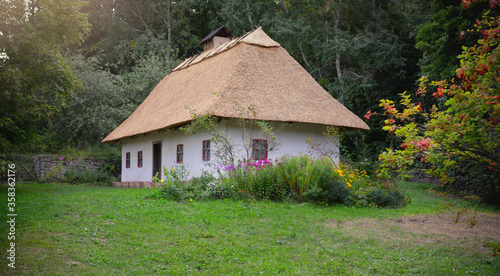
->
xmin=33 ymin=155 xmax=103 ymax=179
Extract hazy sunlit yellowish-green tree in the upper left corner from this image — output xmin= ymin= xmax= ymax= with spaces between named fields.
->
xmin=0 ymin=0 xmax=89 ymax=154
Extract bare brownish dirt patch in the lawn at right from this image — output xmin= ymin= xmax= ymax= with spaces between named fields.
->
xmin=325 ymin=212 xmax=500 ymax=254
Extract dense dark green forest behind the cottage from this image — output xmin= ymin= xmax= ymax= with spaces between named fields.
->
xmin=0 ymin=0 xmax=496 ymax=166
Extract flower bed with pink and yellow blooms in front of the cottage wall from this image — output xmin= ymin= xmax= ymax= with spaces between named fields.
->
xmin=147 ymin=155 xmax=410 ymax=208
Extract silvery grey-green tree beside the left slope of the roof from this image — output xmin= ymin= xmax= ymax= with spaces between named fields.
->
xmin=47 ymin=55 xmax=174 ymax=150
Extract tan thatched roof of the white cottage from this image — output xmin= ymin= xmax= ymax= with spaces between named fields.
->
xmin=103 ymin=28 xmax=369 ymax=142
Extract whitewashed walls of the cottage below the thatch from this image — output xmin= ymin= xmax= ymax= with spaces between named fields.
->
xmin=121 ymin=119 xmax=338 ymax=182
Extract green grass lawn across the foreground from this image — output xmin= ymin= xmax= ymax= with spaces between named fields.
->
xmin=0 ymin=183 xmax=500 ymax=275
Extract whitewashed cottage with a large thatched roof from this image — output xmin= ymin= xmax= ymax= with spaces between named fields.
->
xmin=103 ymin=27 xmax=369 ymax=186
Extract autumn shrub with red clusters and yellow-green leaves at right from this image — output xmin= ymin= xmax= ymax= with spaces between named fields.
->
xmin=374 ymin=4 xmax=500 ymax=203
